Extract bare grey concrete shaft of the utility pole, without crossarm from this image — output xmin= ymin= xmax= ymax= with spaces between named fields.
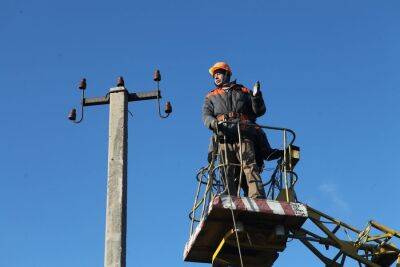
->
xmin=104 ymin=87 xmax=128 ymax=267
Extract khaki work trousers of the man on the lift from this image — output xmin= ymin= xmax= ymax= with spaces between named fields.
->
xmin=219 ymin=139 xmax=265 ymax=198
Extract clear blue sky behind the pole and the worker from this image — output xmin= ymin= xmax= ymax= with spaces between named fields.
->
xmin=0 ymin=0 xmax=400 ymax=267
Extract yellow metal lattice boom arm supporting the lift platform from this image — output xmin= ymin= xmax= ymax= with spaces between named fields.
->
xmin=292 ymin=207 xmax=400 ymax=267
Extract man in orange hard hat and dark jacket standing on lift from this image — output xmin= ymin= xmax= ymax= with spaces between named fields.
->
xmin=203 ymin=62 xmax=270 ymax=198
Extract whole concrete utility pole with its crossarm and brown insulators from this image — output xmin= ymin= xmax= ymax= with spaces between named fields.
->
xmin=69 ymin=74 xmax=172 ymax=267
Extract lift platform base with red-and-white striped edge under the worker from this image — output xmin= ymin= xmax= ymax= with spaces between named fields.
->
xmin=184 ymin=195 xmax=308 ymax=267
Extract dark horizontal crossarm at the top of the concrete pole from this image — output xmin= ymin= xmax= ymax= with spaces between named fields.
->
xmin=82 ymin=87 xmax=162 ymax=107
